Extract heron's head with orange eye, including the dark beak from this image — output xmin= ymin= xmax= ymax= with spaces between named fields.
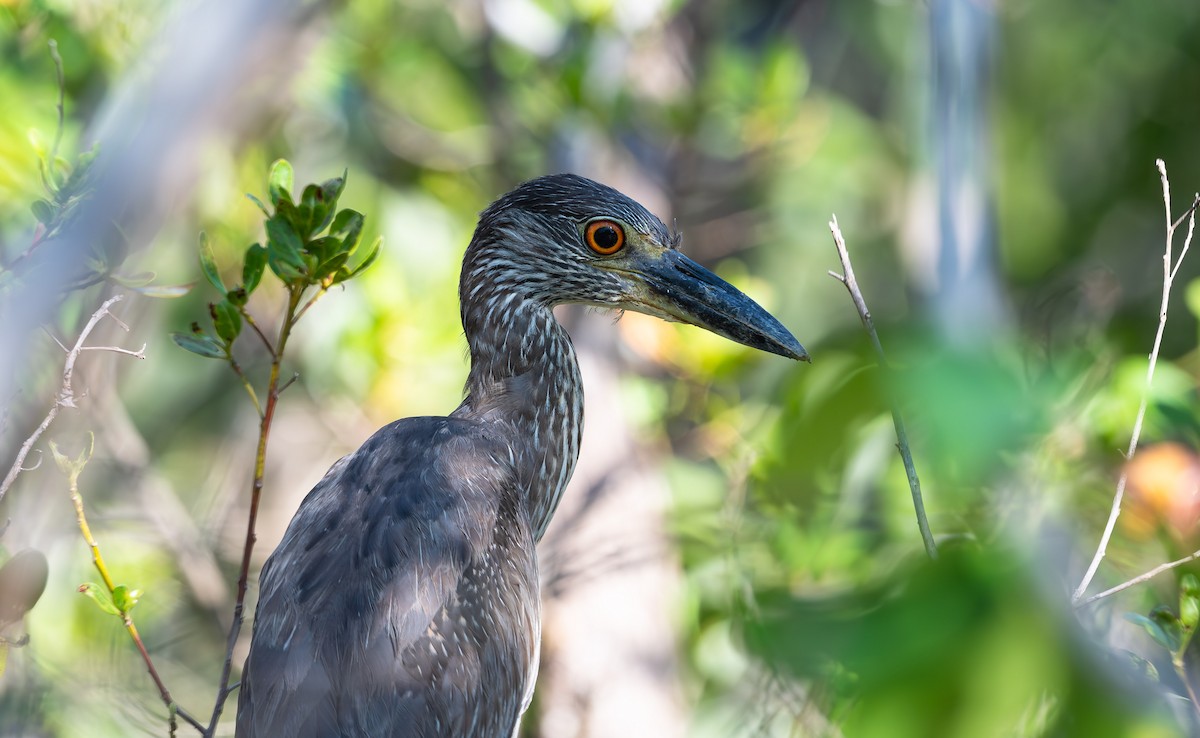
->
xmin=460 ymin=174 xmax=809 ymax=361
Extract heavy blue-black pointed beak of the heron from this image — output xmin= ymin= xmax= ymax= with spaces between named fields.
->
xmin=630 ymin=250 xmax=809 ymax=361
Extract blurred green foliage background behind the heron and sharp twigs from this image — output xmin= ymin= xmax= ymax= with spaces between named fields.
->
xmin=0 ymin=0 xmax=1200 ymax=738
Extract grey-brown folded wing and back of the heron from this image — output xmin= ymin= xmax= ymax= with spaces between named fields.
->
xmin=238 ymin=418 xmax=515 ymax=737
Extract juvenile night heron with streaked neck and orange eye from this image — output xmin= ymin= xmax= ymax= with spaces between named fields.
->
xmin=238 ymin=174 xmax=808 ymax=738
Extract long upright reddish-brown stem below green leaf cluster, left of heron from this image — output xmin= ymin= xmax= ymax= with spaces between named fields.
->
xmin=204 ymin=289 xmax=302 ymax=737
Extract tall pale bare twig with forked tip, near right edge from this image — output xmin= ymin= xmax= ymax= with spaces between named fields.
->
xmin=1070 ymin=158 xmax=1200 ymax=604
